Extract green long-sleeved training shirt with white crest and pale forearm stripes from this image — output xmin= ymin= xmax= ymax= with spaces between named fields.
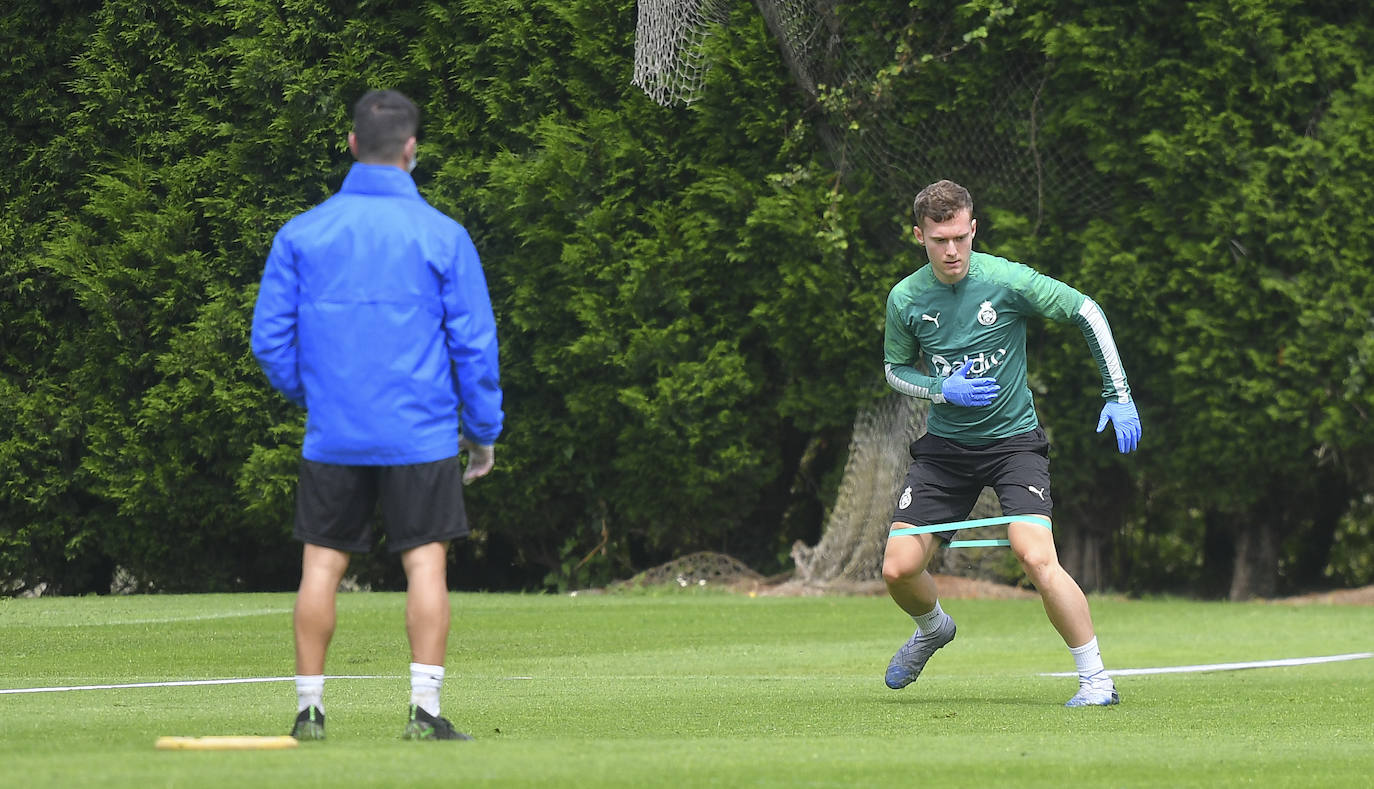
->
xmin=882 ymin=252 xmax=1131 ymax=444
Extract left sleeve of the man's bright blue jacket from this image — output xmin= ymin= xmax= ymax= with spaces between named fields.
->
xmin=253 ymin=232 xmax=305 ymax=408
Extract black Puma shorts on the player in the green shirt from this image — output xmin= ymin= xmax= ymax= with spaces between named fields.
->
xmin=892 ymin=427 xmax=1054 ymax=542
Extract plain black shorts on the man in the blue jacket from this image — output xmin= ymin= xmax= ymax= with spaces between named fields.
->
xmin=294 ymin=455 xmax=469 ymax=554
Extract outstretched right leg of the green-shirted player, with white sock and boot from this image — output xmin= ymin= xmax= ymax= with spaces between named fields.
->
xmin=1007 ymin=522 xmax=1120 ymax=707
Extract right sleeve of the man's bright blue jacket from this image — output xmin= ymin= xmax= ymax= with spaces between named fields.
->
xmin=440 ymin=231 xmax=506 ymax=445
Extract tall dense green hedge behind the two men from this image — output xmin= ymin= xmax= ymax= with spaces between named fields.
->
xmin=0 ymin=0 xmax=1374 ymax=597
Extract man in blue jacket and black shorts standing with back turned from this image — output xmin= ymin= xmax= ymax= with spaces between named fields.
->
xmin=253 ymin=91 xmax=504 ymax=740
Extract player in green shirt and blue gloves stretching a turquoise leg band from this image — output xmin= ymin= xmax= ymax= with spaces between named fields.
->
xmin=882 ymin=180 xmax=1140 ymax=707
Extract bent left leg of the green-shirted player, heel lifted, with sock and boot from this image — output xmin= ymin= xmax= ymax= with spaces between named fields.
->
xmin=882 ymin=524 xmax=955 ymax=690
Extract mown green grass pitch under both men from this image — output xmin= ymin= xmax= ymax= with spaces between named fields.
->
xmin=0 ymin=588 xmax=1374 ymax=789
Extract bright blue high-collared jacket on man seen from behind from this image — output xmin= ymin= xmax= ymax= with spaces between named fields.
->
xmin=253 ymin=164 xmax=504 ymax=466
